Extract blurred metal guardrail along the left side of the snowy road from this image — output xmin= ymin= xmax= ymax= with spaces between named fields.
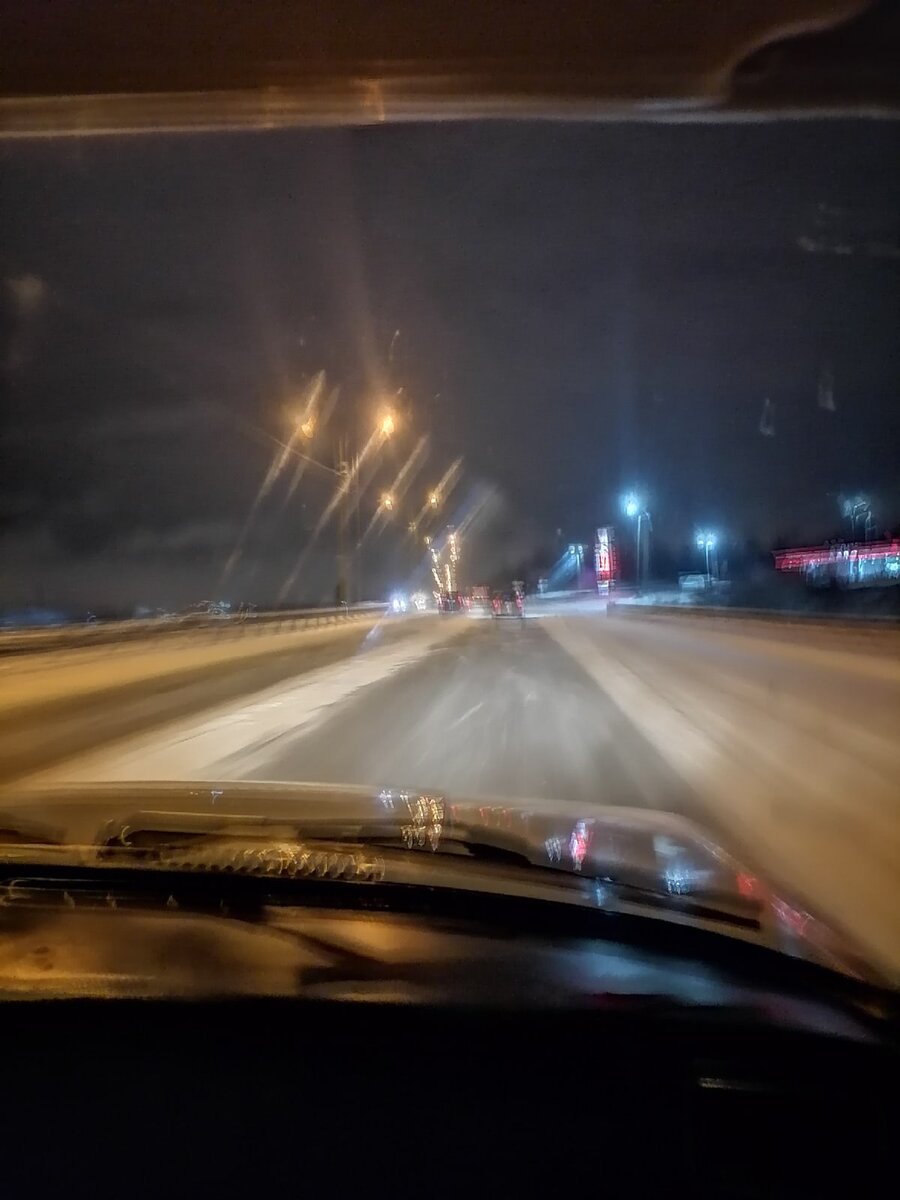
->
xmin=0 ymin=604 xmax=388 ymax=655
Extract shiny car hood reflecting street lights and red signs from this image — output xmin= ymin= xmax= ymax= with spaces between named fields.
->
xmin=0 ymin=782 xmax=884 ymax=983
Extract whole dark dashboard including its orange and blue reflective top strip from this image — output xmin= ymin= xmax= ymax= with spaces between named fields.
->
xmin=2 ymin=869 xmax=898 ymax=1196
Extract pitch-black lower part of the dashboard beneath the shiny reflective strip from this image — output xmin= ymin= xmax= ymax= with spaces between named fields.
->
xmin=4 ymin=997 xmax=896 ymax=1196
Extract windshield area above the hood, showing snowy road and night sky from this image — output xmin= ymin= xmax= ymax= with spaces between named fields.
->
xmin=0 ymin=119 xmax=900 ymax=988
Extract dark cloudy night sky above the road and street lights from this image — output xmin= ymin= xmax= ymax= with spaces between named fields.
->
xmin=0 ymin=121 xmax=900 ymax=608
